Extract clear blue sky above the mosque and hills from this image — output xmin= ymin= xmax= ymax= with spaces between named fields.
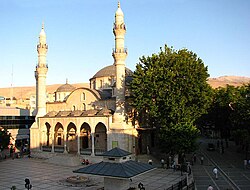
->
xmin=0 ymin=0 xmax=250 ymax=87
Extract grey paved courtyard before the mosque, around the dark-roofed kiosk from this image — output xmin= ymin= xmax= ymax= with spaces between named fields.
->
xmin=0 ymin=157 xmax=186 ymax=190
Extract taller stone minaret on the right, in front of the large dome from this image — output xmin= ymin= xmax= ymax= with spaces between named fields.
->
xmin=112 ymin=2 xmax=127 ymax=123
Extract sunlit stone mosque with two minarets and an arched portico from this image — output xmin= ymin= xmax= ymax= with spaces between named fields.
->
xmin=30 ymin=3 xmax=143 ymax=156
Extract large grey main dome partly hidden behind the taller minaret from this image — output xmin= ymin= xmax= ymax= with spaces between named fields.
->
xmin=92 ymin=65 xmax=133 ymax=78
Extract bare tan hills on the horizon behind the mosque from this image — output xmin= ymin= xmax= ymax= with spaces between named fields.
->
xmin=0 ymin=76 xmax=250 ymax=99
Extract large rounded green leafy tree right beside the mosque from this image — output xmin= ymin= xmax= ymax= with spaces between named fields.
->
xmin=131 ymin=46 xmax=211 ymax=153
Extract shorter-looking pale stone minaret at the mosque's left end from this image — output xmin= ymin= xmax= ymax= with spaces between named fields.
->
xmin=35 ymin=24 xmax=48 ymax=117
